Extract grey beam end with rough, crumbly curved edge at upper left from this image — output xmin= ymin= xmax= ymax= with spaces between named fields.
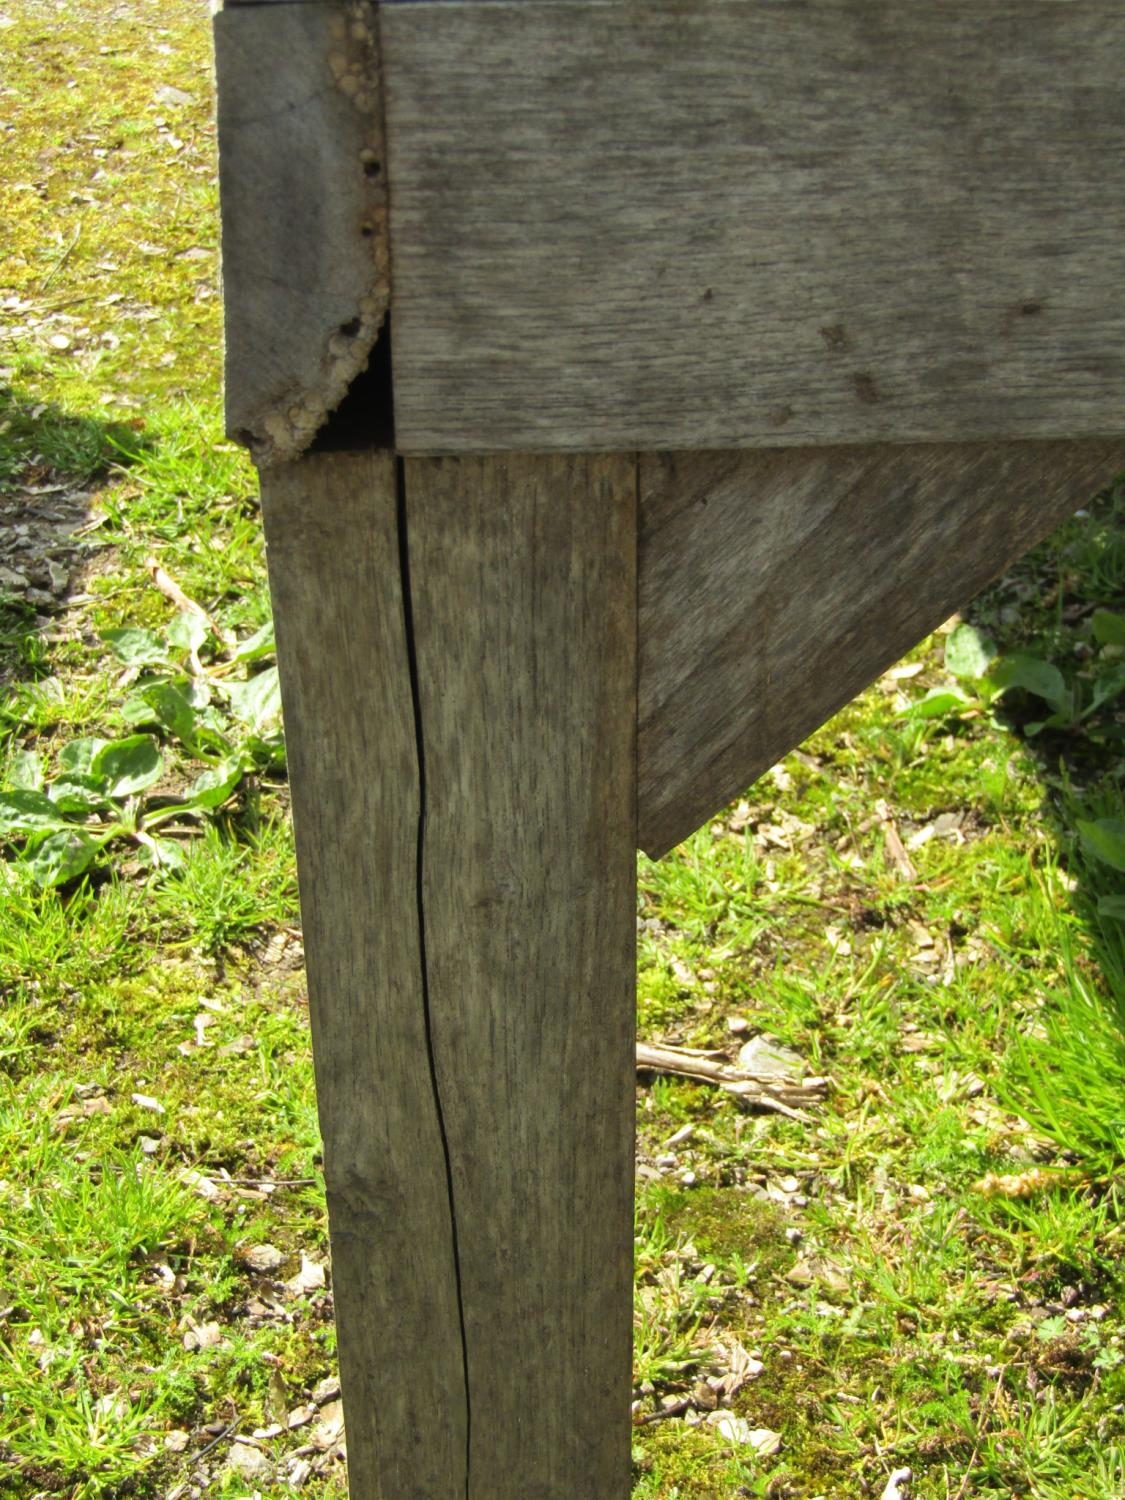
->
xmin=215 ymin=0 xmax=389 ymax=468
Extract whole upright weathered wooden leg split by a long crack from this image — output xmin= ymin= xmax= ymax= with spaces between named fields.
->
xmin=263 ymin=453 xmax=636 ymax=1500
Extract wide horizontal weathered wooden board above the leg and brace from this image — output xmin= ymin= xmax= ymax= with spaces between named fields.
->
xmin=380 ymin=0 xmax=1125 ymax=453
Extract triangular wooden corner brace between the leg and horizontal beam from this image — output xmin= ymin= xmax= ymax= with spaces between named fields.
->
xmin=638 ymin=441 xmax=1125 ymax=857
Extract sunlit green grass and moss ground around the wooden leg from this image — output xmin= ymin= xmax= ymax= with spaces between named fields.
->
xmin=0 ymin=0 xmax=1125 ymax=1500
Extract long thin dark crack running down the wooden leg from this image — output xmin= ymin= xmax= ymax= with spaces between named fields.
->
xmin=395 ymin=459 xmax=473 ymax=1500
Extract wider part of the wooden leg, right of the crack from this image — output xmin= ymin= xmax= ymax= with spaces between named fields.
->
xmin=405 ymin=458 xmax=636 ymax=1500
